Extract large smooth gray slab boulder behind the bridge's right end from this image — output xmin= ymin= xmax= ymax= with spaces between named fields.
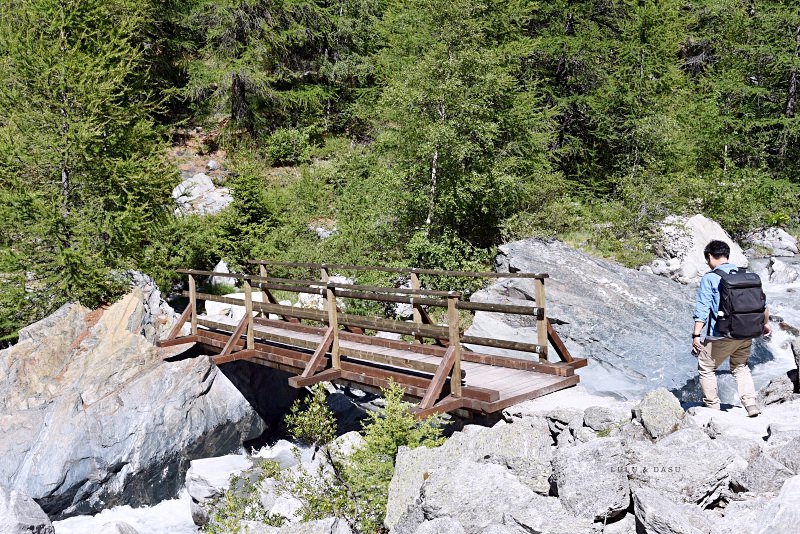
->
xmin=476 ymin=239 xmax=697 ymax=399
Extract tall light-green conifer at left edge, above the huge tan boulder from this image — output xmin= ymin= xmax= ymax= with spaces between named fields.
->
xmin=0 ymin=0 xmax=174 ymax=342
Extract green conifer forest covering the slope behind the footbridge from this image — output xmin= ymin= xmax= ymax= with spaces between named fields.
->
xmin=0 ymin=0 xmax=800 ymax=343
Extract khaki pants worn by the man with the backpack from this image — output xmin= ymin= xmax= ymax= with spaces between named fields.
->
xmin=697 ymin=339 xmax=756 ymax=410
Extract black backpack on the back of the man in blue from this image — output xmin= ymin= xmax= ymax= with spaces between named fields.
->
xmin=708 ymin=268 xmax=767 ymax=339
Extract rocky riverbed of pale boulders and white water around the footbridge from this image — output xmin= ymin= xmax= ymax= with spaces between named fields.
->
xmin=0 ymin=219 xmax=800 ymax=534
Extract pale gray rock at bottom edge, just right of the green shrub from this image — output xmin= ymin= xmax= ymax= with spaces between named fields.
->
xmin=421 ymin=460 xmax=536 ymax=534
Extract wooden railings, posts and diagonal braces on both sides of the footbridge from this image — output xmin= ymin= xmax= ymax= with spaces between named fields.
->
xmin=161 ymin=260 xmax=585 ymax=409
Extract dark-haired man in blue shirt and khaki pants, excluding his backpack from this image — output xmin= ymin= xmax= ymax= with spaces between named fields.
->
xmin=692 ymin=240 xmax=772 ymax=417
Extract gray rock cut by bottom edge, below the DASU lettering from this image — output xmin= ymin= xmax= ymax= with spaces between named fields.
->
xmin=633 ymin=488 xmax=712 ymax=534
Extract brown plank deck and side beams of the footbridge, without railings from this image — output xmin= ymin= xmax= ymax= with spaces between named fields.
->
xmin=170 ymin=319 xmax=579 ymax=413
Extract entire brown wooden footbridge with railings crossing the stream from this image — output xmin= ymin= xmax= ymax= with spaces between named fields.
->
xmin=159 ymin=260 xmax=586 ymax=417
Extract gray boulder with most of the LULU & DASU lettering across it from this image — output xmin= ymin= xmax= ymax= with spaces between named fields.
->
xmin=628 ymin=427 xmax=747 ymax=508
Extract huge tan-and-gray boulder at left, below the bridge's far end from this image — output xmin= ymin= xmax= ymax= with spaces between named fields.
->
xmin=0 ymin=290 xmax=263 ymax=518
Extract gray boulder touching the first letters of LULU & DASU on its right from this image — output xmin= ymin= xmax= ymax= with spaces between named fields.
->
xmin=553 ymin=438 xmax=630 ymax=521
